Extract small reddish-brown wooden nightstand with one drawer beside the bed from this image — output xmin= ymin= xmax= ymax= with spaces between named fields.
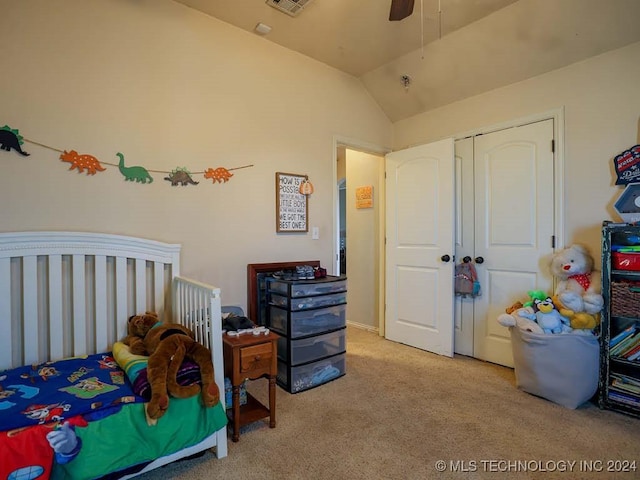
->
xmin=222 ymin=332 xmax=280 ymax=442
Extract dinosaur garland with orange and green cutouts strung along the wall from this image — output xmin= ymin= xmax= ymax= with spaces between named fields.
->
xmin=0 ymin=125 xmax=253 ymax=187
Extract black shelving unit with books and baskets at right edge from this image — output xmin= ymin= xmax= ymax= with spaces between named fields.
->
xmin=599 ymin=222 xmax=640 ymax=417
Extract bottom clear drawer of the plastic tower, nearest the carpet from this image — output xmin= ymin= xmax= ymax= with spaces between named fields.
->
xmin=277 ymin=353 xmax=346 ymax=393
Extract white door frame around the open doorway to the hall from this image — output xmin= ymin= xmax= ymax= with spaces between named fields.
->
xmin=332 ymin=135 xmax=391 ymax=337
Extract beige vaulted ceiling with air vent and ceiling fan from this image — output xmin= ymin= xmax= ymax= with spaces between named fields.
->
xmin=176 ymin=0 xmax=640 ymax=121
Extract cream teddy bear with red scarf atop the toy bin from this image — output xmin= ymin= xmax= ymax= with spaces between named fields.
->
xmin=551 ymin=244 xmax=604 ymax=329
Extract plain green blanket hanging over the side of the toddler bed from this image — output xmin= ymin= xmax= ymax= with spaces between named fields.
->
xmin=51 ymin=396 xmax=227 ymax=480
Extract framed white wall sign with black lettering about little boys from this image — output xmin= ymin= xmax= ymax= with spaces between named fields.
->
xmin=276 ymin=172 xmax=309 ymax=232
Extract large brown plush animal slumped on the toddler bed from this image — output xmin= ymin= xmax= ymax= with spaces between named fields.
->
xmin=123 ymin=312 xmax=220 ymax=419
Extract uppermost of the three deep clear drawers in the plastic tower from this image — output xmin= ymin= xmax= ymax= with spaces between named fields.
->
xmin=269 ymin=305 xmax=347 ymax=339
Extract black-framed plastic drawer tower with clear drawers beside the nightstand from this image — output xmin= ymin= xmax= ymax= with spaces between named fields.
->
xmin=267 ymin=276 xmax=347 ymax=393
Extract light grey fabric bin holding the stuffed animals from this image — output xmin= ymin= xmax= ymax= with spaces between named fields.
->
xmin=509 ymin=327 xmax=600 ymax=409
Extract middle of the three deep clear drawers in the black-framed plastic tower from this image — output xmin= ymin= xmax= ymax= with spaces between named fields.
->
xmin=278 ymin=328 xmax=347 ymax=365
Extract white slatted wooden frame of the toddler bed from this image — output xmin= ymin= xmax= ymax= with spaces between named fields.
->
xmin=0 ymin=232 xmax=227 ymax=478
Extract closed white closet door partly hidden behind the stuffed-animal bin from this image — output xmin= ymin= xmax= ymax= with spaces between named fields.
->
xmin=474 ymin=120 xmax=554 ymax=366
